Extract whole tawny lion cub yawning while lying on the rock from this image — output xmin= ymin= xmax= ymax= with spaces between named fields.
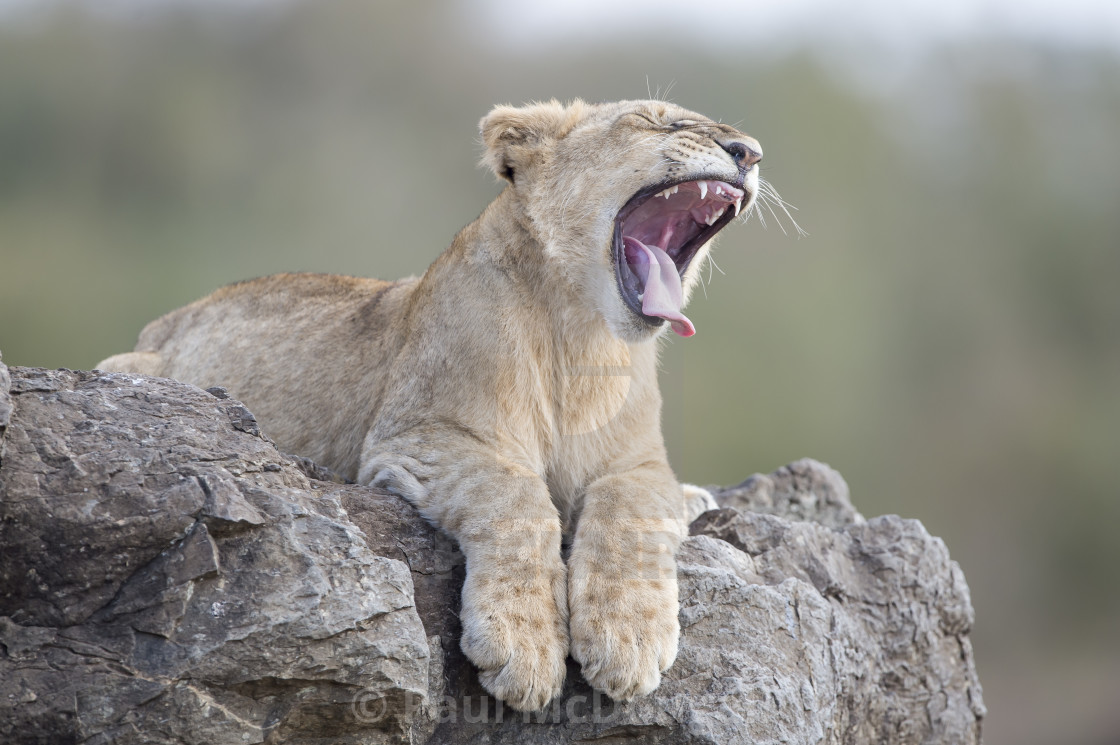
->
xmin=100 ymin=101 xmax=762 ymax=710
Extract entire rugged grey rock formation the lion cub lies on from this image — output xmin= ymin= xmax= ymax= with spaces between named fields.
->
xmin=0 ymin=362 xmax=983 ymax=745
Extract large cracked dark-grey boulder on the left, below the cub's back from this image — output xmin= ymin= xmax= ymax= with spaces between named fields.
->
xmin=0 ymin=358 xmax=436 ymax=745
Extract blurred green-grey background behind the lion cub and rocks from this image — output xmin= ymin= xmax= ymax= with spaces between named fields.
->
xmin=0 ymin=0 xmax=1120 ymax=745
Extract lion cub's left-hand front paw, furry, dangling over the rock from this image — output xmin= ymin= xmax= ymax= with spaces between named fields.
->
xmin=461 ymin=564 xmax=568 ymax=711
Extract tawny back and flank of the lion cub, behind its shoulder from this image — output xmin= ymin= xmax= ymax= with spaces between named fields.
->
xmin=99 ymin=273 xmax=417 ymax=478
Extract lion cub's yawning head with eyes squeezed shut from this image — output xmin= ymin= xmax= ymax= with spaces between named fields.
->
xmin=482 ymin=100 xmax=762 ymax=342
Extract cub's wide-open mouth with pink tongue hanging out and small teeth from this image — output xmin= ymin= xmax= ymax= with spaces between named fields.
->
xmin=612 ymin=180 xmax=746 ymax=336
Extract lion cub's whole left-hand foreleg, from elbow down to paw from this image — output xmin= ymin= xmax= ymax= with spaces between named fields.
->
xmin=358 ymin=443 xmax=568 ymax=711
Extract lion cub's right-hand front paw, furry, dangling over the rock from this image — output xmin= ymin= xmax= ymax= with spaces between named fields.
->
xmin=569 ymin=574 xmax=681 ymax=701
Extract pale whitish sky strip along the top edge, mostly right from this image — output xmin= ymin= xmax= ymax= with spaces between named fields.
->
xmin=0 ymin=0 xmax=1120 ymax=49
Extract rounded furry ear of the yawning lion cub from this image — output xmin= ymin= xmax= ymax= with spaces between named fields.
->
xmin=478 ymin=99 xmax=587 ymax=184
